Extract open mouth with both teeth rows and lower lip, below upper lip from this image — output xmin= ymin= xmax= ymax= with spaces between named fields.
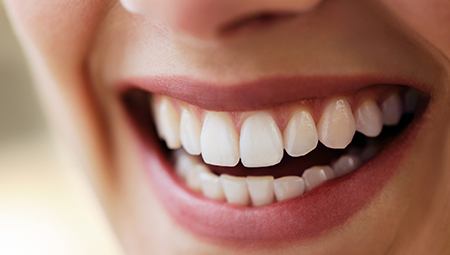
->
xmin=122 ymin=77 xmax=429 ymax=243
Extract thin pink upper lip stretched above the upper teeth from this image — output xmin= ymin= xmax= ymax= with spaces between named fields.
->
xmin=119 ymin=75 xmax=427 ymax=111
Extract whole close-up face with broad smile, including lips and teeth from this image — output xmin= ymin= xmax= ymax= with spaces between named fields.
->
xmin=4 ymin=0 xmax=450 ymax=255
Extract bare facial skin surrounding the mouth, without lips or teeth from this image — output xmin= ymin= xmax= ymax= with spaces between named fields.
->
xmin=5 ymin=0 xmax=450 ymax=254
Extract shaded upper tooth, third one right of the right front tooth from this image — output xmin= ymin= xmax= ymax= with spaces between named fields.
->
xmin=355 ymin=100 xmax=383 ymax=137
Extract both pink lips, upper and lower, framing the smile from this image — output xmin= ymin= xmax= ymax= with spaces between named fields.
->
xmin=121 ymin=76 xmax=430 ymax=246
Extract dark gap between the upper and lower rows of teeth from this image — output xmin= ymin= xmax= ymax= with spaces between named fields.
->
xmin=208 ymin=144 xmax=344 ymax=178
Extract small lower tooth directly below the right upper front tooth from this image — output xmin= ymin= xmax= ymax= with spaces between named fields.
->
xmin=247 ymin=176 xmax=274 ymax=206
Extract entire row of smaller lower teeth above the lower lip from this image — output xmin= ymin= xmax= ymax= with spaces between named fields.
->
xmin=175 ymin=144 xmax=378 ymax=206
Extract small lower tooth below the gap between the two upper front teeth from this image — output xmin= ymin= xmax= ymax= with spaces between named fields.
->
xmin=220 ymin=174 xmax=250 ymax=205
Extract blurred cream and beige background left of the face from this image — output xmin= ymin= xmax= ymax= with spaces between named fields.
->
xmin=0 ymin=4 xmax=121 ymax=255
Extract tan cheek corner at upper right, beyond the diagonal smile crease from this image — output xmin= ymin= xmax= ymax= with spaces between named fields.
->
xmin=381 ymin=0 xmax=450 ymax=57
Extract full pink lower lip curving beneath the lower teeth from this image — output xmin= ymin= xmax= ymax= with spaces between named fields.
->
xmin=135 ymin=112 xmax=421 ymax=246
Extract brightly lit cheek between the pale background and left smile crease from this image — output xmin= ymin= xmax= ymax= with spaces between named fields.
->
xmin=5 ymin=0 xmax=115 ymax=187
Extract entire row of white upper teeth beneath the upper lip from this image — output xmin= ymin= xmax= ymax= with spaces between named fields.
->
xmin=153 ymin=93 xmax=412 ymax=167
